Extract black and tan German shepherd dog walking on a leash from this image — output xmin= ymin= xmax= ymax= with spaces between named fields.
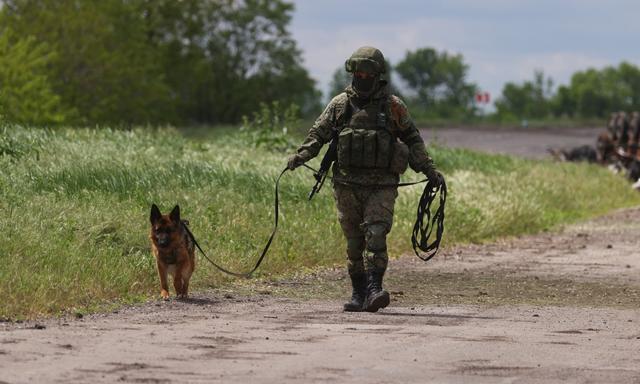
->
xmin=149 ymin=204 xmax=196 ymax=300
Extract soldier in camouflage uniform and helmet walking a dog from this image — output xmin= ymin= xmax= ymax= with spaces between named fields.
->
xmin=287 ymin=47 xmax=442 ymax=312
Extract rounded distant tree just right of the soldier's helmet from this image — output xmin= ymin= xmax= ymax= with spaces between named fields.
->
xmin=395 ymin=48 xmax=477 ymax=117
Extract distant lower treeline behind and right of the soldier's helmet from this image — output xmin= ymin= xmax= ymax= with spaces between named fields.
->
xmin=330 ymin=48 xmax=640 ymax=121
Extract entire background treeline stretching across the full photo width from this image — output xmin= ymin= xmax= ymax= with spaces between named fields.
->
xmin=0 ymin=0 xmax=640 ymax=125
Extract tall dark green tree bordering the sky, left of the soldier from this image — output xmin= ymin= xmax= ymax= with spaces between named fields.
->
xmin=146 ymin=0 xmax=319 ymax=122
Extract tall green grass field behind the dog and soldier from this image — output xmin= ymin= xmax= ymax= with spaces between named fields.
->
xmin=0 ymin=127 xmax=640 ymax=319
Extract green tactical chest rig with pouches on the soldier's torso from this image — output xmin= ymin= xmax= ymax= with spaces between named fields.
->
xmin=338 ymin=99 xmax=409 ymax=174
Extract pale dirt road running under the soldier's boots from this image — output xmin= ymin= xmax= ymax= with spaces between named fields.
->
xmin=0 ymin=209 xmax=640 ymax=384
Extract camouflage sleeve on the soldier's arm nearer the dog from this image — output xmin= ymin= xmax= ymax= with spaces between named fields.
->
xmin=297 ymin=94 xmax=346 ymax=162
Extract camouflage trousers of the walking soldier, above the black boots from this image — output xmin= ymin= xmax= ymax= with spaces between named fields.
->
xmin=333 ymin=184 xmax=398 ymax=275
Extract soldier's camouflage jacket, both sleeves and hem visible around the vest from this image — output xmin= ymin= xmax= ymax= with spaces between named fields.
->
xmin=297 ymin=83 xmax=433 ymax=184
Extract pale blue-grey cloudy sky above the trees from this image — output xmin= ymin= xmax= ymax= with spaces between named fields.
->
xmin=291 ymin=0 xmax=640 ymax=105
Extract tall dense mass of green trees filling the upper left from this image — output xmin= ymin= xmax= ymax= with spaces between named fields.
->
xmin=0 ymin=0 xmax=320 ymax=124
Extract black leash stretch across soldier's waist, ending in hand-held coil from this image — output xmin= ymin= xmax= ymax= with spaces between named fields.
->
xmin=302 ymin=164 xmax=447 ymax=261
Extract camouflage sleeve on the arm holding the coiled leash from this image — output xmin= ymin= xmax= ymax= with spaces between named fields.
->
xmin=390 ymin=96 xmax=434 ymax=172
